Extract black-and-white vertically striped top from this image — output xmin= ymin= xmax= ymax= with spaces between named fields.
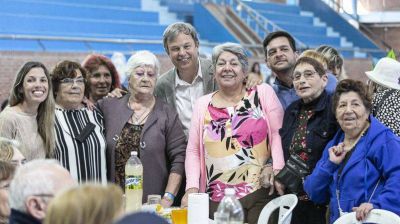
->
xmin=54 ymin=106 xmax=107 ymax=184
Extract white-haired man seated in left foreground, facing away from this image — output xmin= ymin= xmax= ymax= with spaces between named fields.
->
xmin=9 ymin=159 xmax=75 ymax=224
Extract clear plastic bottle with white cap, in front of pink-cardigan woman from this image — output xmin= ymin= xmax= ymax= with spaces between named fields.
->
xmin=215 ymin=188 xmax=244 ymax=224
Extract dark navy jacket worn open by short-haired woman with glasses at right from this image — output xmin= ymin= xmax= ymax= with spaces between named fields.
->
xmin=279 ymin=91 xmax=339 ymax=171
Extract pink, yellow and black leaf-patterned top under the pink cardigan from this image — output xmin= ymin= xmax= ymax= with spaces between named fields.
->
xmin=203 ymin=89 xmax=270 ymax=202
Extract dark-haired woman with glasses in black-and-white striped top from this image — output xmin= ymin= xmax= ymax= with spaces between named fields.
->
xmin=51 ymin=61 xmax=107 ymax=183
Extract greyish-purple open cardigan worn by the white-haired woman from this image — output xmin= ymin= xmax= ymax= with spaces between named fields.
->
xmin=98 ymin=94 xmax=186 ymax=202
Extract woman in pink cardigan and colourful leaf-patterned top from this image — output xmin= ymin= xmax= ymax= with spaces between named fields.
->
xmin=182 ymin=43 xmax=284 ymax=223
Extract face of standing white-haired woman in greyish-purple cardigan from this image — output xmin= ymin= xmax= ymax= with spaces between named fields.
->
xmin=129 ymin=65 xmax=157 ymax=95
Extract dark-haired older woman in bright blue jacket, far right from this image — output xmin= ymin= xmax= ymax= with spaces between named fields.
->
xmin=304 ymin=79 xmax=400 ymax=223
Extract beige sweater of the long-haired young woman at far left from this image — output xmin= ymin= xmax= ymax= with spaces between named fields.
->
xmin=0 ymin=107 xmax=46 ymax=161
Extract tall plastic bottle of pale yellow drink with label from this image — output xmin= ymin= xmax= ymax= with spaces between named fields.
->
xmin=125 ymin=151 xmax=143 ymax=212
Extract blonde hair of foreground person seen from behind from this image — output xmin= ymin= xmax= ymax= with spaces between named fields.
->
xmin=44 ymin=184 xmax=123 ymax=224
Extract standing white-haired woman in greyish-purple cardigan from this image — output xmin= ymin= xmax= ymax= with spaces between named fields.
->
xmin=98 ymin=51 xmax=186 ymax=207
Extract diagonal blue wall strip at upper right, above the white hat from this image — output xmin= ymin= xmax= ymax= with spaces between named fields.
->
xmin=299 ymin=0 xmax=378 ymax=49
